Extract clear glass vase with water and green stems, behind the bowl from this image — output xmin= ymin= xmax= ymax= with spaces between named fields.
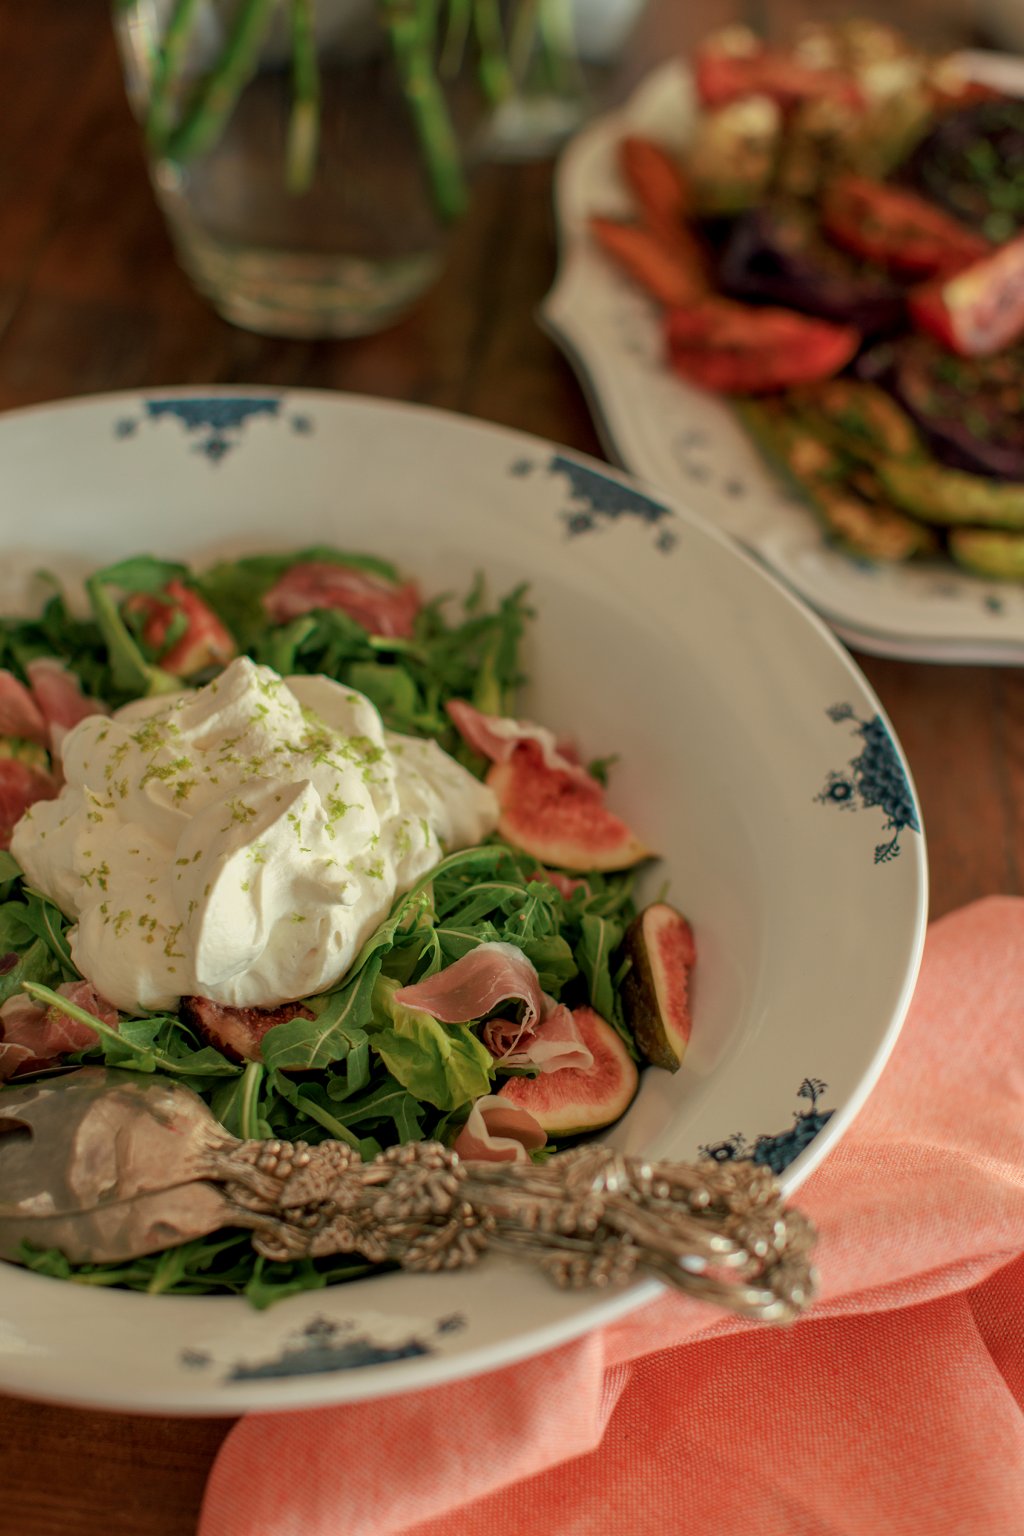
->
xmin=115 ymin=0 xmax=484 ymax=336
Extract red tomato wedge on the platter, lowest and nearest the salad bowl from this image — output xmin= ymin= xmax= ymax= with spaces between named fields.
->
xmin=666 ymin=300 xmax=861 ymax=395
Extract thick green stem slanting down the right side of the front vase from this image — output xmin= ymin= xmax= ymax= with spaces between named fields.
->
xmin=379 ymin=0 xmax=467 ymax=220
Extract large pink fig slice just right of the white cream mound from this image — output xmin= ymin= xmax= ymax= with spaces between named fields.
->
xmin=487 ymin=742 xmax=649 ymax=871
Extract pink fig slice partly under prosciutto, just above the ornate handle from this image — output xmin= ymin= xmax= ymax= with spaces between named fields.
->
xmin=499 ymin=1008 xmax=640 ymax=1137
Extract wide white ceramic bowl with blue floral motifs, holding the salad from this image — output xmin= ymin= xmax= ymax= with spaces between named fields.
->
xmin=0 ymin=389 xmax=926 ymax=1413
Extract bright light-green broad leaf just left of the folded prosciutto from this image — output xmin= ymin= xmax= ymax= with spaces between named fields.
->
xmin=370 ymin=977 xmax=494 ymax=1109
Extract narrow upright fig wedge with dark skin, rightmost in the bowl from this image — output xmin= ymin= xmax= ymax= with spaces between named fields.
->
xmin=622 ymin=902 xmax=697 ymax=1072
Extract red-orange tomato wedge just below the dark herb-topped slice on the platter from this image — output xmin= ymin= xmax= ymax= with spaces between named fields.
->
xmin=821 ymin=175 xmax=990 ymax=278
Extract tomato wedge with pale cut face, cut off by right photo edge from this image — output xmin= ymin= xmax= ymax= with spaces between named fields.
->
xmin=909 ymin=235 xmax=1024 ymax=358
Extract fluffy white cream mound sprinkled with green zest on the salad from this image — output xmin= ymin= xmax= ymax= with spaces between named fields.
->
xmin=11 ymin=656 xmax=497 ymax=1011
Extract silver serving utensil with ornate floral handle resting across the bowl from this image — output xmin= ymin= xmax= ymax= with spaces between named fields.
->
xmin=0 ymin=1066 xmax=815 ymax=1322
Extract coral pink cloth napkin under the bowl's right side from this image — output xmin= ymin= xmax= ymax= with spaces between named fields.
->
xmin=200 ymin=899 xmax=1024 ymax=1536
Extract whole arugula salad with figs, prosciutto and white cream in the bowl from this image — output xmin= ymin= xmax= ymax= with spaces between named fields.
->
xmin=0 ymin=548 xmax=695 ymax=1304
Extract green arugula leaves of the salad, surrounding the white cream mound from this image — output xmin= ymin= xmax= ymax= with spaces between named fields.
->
xmin=0 ymin=548 xmax=647 ymax=1306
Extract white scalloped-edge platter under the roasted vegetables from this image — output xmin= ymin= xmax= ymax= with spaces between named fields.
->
xmin=542 ymin=54 xmax=1024 ymax=665
